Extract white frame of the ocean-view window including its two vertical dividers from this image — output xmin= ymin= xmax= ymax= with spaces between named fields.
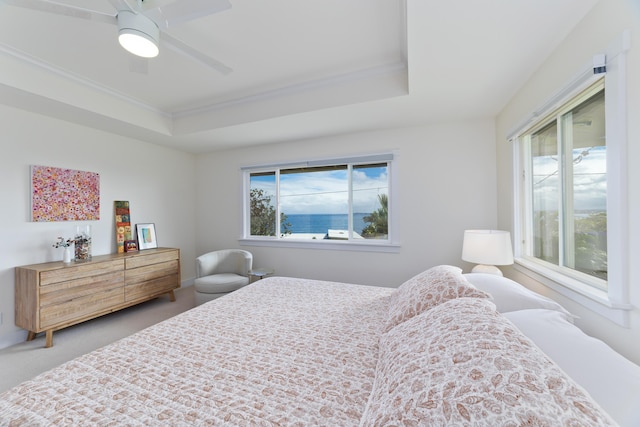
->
xmin=238 ymin=151 xmax=400 ymax=253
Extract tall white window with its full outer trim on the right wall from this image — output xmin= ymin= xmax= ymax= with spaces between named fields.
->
xmin=508 ymin=31 xmax=632 ymax=327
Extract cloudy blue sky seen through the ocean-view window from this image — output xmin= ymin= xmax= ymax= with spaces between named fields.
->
xmin=252 ymin=168 xmax=388 ymax=215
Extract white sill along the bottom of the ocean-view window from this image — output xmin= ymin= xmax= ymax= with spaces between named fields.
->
xmin=238 ymin=238 xmax=400 ymax=253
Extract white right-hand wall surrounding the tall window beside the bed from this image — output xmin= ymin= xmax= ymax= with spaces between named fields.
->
xmin=496 ymin=0 xmax=640 ymax=364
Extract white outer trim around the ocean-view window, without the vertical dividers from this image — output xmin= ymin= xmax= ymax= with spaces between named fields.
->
xmin=238 ymin=150 xmax=401 ymax=253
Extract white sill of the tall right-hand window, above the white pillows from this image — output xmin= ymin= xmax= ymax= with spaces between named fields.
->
xmin=514 ymin=258 xmax=632 ymax=328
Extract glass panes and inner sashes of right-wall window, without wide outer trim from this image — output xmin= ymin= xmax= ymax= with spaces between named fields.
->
xmin=521 ymin=79 xmax=608 ymax=289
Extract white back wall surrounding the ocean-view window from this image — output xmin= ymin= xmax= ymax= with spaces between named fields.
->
xmin=197 ymin=120 xmax=497 ymax=287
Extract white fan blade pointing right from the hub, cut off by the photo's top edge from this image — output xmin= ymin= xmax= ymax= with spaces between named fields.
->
xmin=144 ymin=0 xmax=231 ymax=27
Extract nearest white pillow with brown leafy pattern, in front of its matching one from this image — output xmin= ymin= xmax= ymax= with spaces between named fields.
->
xmin=360 ymin=298 xmax=615 ymax=426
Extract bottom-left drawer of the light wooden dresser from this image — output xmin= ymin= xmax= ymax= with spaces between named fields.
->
xmin=40 ymin=287 xmax=124 ymax=329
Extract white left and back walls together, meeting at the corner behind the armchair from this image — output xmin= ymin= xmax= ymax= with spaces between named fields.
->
xmin=0 ymin=106 xmax=496 ymax=348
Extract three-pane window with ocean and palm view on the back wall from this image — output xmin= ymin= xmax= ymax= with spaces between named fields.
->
xmin=243 ymin=154 xmax=393 ymax=251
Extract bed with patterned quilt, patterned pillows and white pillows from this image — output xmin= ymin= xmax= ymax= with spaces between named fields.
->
xmin=0 ymin=266 xmax=640 ymax=426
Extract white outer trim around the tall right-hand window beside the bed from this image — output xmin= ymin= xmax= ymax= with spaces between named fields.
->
xmin=508 ymin=31 xmax=632 ymax=327
